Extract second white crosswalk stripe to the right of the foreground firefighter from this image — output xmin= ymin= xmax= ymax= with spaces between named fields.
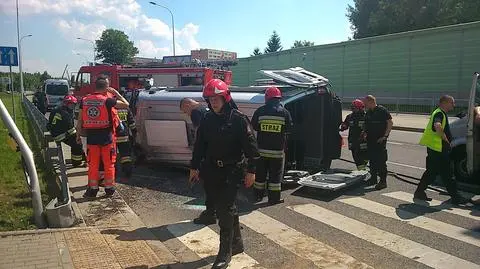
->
xmin=287 ymin=204 xmax=478 ymax=269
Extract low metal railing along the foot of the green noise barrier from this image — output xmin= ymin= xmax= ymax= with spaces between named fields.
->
xmin=342 ymin=96 xmax=468 ymax=115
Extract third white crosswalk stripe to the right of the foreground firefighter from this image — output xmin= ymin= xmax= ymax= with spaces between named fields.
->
xmin=339 ymin=197 xmax=480 ymax=247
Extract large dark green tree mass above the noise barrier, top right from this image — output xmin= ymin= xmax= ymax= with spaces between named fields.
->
xmin=347 ymin=0 xmax=480 ymax=38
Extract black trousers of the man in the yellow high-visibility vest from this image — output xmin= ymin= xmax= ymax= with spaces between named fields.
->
xmin=416 ymin=148 xmax=457 ymax=197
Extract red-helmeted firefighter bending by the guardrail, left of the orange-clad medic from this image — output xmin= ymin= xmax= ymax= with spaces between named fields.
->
xmin=47 ymin=95 xmax=85 ymax=167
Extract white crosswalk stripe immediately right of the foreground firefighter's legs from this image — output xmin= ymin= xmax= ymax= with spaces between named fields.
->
xmin=240 ymin=211 xmax=372 ymax=268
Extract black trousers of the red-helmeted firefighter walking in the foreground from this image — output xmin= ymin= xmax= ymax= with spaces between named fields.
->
xmin=200 ymin=161 xmax=245 ymax=242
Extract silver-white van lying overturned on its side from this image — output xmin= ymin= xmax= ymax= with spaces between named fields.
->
xmin=136 ymin=67 xmax=342 ymax=176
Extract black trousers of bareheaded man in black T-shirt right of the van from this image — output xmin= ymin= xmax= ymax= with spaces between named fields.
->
xmin=367 ymin=141 xmax=388 ymax=181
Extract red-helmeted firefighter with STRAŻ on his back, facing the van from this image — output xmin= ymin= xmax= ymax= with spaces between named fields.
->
xmin=252 ymin=87 xmax=293 ymax=205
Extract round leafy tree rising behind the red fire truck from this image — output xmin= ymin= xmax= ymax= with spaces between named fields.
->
xmin=95 ymin=29 xmax=138 ymax=64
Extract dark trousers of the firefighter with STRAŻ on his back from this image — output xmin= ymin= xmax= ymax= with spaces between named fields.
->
xmin=254 ymin=157 xmax=285 ymax=201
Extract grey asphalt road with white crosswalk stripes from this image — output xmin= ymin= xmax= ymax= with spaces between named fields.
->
xmin=118 ymin=131 xmax=480 ymax=269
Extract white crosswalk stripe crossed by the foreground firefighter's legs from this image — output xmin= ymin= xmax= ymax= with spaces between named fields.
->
xmin=167 ymin=221 xmax=258 ymax=269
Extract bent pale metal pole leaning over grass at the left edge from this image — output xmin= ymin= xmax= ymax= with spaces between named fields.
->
xmin=0 ymin=100 xmax=45 ymax=228
